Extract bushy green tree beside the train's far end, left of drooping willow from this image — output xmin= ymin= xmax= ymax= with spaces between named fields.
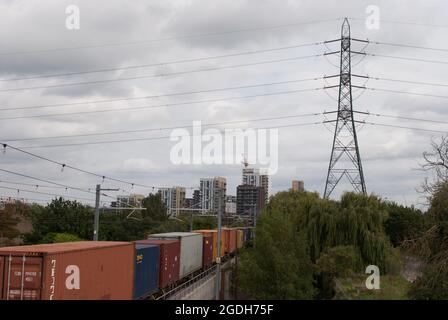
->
xmin=238 ymin=211 xmax=316 ymax=299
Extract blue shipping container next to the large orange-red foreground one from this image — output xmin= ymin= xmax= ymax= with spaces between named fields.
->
xmin=134 ymin=244 xmax=160 ymax=299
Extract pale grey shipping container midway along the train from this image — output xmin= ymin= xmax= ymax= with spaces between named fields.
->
xmin=149 ymin=232 xmax=203 ymax=278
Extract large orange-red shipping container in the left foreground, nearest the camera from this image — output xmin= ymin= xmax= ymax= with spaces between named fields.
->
xmin=0 ymin=241 xmax=135 ymax=300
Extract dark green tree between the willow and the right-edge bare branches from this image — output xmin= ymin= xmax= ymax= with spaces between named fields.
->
xmin=384 ymin=202 xmax=426 ymax=246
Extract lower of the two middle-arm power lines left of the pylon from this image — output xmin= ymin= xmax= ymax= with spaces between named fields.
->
xmin=0 ymin=87 xmax=324 ymax=121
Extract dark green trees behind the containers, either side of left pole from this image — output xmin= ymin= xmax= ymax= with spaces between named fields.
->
xmin=24 ymin=195 xmax=180 ymax=244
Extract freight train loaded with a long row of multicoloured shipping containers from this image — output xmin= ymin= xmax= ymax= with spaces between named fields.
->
xmin=0 ymin=227 xmax=253 ymax=300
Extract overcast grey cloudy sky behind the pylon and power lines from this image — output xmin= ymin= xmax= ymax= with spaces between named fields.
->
xmin=0 ymin=0 xmax=448 ymax=209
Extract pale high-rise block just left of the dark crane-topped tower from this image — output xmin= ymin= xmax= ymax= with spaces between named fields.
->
xmin=199 ymin=177 xmax=227 ymax=215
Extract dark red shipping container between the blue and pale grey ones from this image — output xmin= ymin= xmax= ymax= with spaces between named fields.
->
xmin=135 ymin=239 xmax=180 ymax=289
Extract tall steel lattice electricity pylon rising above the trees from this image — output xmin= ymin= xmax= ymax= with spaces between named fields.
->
xmin=324 ymin=18 xmax=366 ymax=198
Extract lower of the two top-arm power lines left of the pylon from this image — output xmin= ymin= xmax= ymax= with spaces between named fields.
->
xmin=0 ymin=54 xmax=323 ymax=92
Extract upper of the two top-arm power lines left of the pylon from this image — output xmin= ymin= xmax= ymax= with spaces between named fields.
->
xmin=0 ymin=42 xmax=323 ymax=82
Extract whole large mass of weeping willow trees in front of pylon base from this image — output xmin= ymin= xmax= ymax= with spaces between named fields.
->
xmin=240 ymin=191 xmax=392 ymax=299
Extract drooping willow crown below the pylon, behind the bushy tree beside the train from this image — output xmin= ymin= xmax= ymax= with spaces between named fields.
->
xmin=266 ymin=192 xmax=389 ymax=270
